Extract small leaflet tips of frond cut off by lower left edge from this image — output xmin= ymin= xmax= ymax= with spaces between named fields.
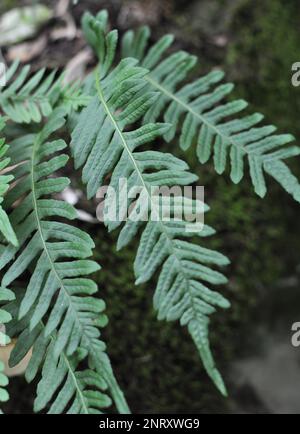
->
xmin=0 ymin=287 xmax=14 ymax=413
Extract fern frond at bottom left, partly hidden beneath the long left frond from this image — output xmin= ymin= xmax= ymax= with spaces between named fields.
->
xmin=6 ymin=291 xmax=112 ymax=414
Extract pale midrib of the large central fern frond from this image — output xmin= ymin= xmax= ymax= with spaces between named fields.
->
xmin=96 ymin=70 xmax=197 ymax=332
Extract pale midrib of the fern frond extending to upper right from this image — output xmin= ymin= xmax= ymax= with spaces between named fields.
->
xmin=145 ymin=74 xmax=254 ymax=157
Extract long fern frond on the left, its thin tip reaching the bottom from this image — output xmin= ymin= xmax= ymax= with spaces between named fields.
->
xmin=0 ymin=110 xmax=128 ymax=412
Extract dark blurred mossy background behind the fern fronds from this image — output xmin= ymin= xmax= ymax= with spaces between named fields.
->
xmin=0 ymin=0 xmax=300 ymax=414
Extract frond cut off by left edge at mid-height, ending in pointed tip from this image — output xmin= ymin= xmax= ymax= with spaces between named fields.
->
xmin=0 ymin=117 xmax=18 ymax=246
